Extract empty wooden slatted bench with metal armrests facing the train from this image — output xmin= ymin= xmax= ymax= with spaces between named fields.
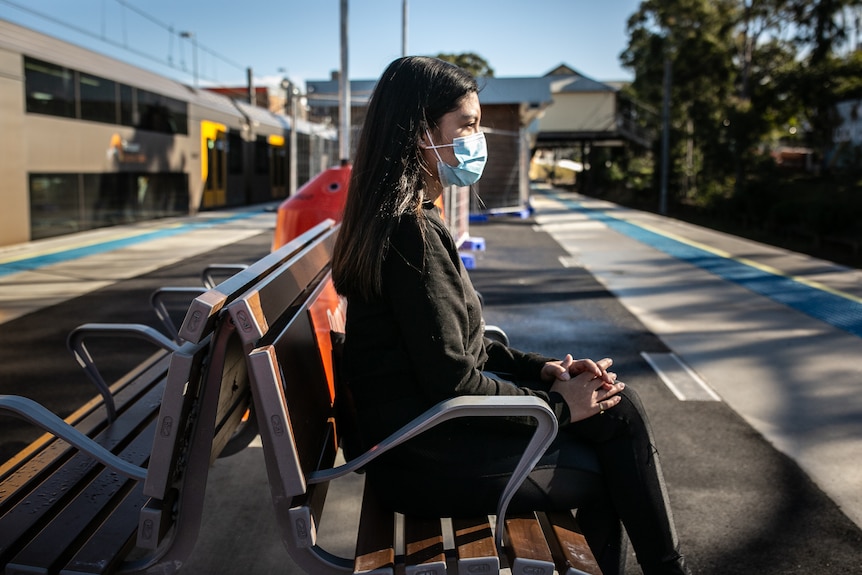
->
xmin=0 ymin=221 xmax=334 ymax=575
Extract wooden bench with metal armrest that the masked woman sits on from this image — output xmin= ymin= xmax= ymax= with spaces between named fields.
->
xmin=240 ymin=256 xmax=600 ymax=575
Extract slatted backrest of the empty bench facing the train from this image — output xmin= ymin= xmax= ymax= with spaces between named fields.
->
xmin=133 ymin=221 xmax=340 ymax=563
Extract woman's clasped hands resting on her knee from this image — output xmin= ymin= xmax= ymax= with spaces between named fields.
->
xmin=542 ymin=354 xmax=626 ymax=422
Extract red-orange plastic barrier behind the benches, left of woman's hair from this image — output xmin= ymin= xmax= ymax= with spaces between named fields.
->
xmin=272 ymin=165 xmax=351 ymax=251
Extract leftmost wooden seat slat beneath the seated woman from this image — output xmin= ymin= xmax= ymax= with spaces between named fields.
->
xmin=353 ymin=485 xmax=395 ymax=575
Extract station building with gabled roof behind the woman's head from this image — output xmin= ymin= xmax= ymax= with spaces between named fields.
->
xmin=307 ymin=64 xmax=652 ymax=214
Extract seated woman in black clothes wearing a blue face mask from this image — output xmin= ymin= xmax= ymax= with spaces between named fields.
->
xmin=333 ymin=57 xmax=688 ymax=575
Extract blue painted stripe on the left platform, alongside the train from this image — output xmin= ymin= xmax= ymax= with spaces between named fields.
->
xmin=0 ymin=211 xmax=260 ymax=277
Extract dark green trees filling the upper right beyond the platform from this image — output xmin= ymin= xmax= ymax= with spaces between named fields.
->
xmin=612 ymin=0 xmax=862 ymax=266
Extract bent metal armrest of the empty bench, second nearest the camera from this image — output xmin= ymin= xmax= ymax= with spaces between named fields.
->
xmin=66 ymin=323 xmax=179 ymax=422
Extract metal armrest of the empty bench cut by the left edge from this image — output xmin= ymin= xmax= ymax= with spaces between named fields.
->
xmin=0 ymin=395 xmax=147 ymax=480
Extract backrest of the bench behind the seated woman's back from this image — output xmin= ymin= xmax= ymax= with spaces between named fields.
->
xmin=249 ymin=277 xmax=352 ymax=572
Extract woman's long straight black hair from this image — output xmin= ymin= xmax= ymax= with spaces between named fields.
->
xmin=332 ymin=56 xmax=479 ymax=300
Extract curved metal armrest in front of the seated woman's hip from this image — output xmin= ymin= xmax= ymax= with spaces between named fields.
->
xmin=306 ymin=395 xmax=557 ymax=549
